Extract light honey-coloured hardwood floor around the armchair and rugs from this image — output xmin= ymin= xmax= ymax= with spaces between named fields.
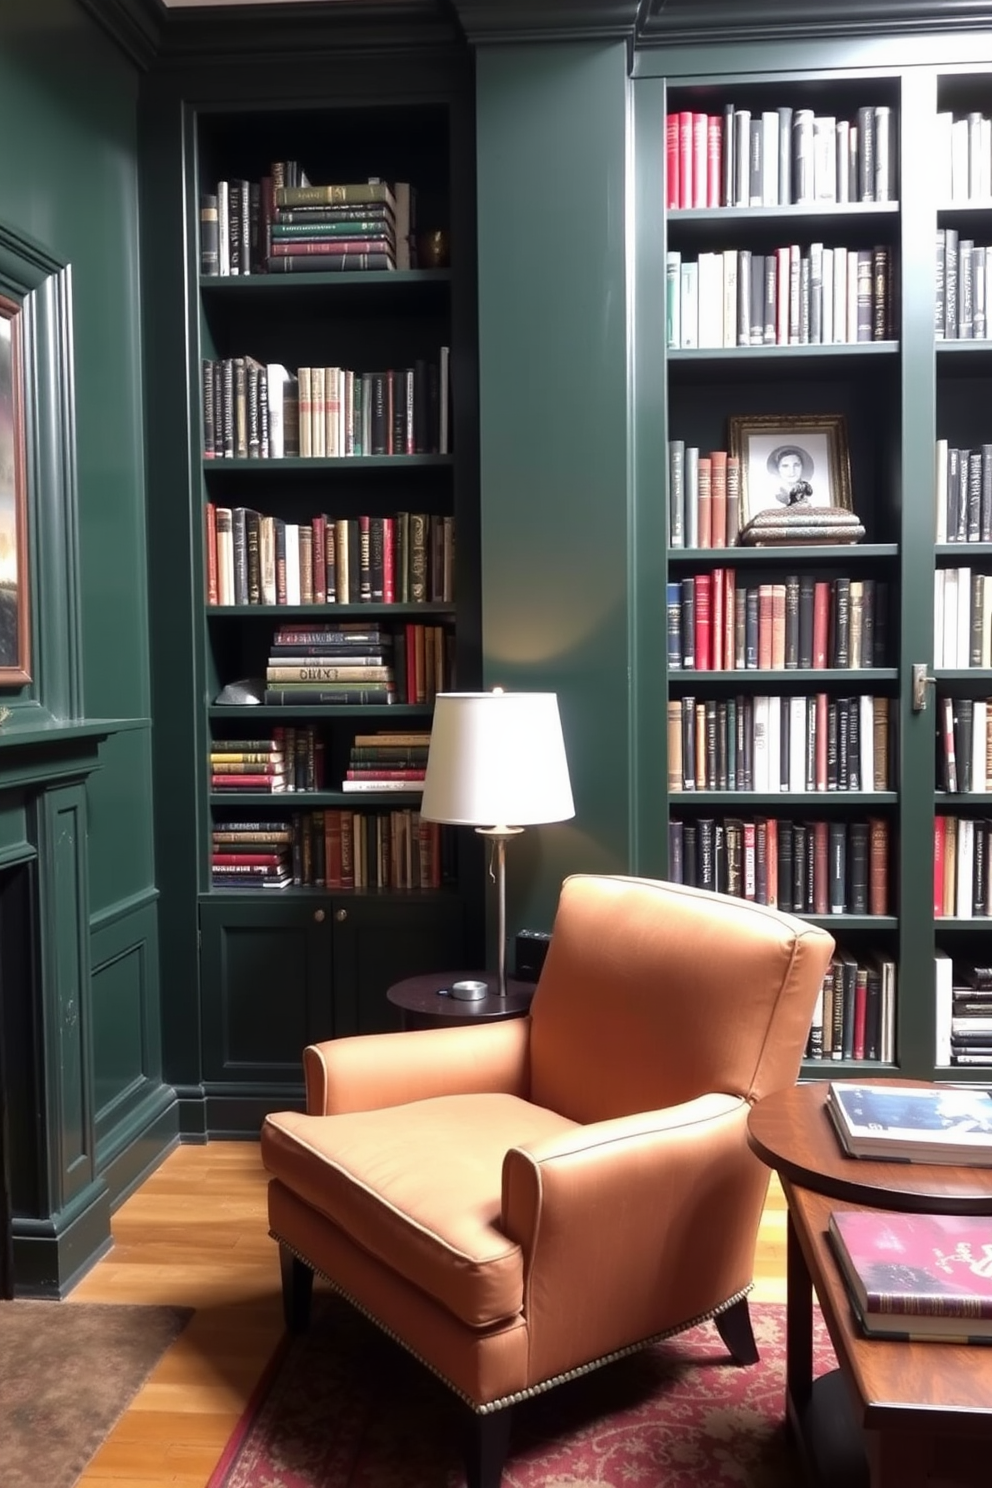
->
xmin=68 ymin=1141 xmax=785 ymax=1488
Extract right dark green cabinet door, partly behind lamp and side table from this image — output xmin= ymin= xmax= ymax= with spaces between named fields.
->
xmin=333 ymin=894 xmax=466 ymax=1034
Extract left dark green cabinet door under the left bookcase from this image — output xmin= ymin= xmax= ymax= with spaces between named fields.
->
xmin=199 ymin=894 xmax=338 ymax=1086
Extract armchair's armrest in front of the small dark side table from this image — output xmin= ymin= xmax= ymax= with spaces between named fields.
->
xmin=303 ymin=1018 xmax=531 ymax=1116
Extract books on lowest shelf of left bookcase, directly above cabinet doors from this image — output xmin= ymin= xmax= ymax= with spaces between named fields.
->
xmin=211 ymin=806 xmax=454 ymax=890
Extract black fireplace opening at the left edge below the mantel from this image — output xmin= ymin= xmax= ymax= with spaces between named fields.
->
xmin=0 ymin=863 xmax=37 ymax=1298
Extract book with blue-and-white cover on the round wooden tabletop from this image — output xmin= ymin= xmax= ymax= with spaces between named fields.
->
xmin=825 ymin=1080 xmax=992 ymax=1167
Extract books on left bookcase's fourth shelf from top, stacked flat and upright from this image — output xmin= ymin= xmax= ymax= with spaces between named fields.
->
xmin=262 ymin=620 xmax=455 ymax=707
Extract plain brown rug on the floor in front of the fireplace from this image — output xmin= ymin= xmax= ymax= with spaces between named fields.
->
xmin=0 ymin=1299 xmax=193 ymax=1488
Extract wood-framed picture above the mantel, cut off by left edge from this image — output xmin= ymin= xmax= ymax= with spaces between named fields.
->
xmin=0 ymin=295 xmax=31 ymax=687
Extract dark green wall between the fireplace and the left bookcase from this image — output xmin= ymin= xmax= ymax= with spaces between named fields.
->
xmin=0 ymin=0 xmax=162 ymax=1202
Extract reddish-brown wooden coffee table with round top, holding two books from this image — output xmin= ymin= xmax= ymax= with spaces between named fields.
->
xmin=748 ymin=1080 xmax=992 ymax=1488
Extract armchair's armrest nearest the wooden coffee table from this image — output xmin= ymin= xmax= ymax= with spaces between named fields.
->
xmin=501 ymin=1094 xmax=767 ymax=1378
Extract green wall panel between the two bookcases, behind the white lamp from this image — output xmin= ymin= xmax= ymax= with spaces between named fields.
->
xmin=476 ymin=42 xmax=631 ymax=940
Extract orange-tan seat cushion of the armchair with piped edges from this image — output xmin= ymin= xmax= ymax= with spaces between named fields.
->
xmin=262 ymin=1094 xmax=576 ymax=1329
